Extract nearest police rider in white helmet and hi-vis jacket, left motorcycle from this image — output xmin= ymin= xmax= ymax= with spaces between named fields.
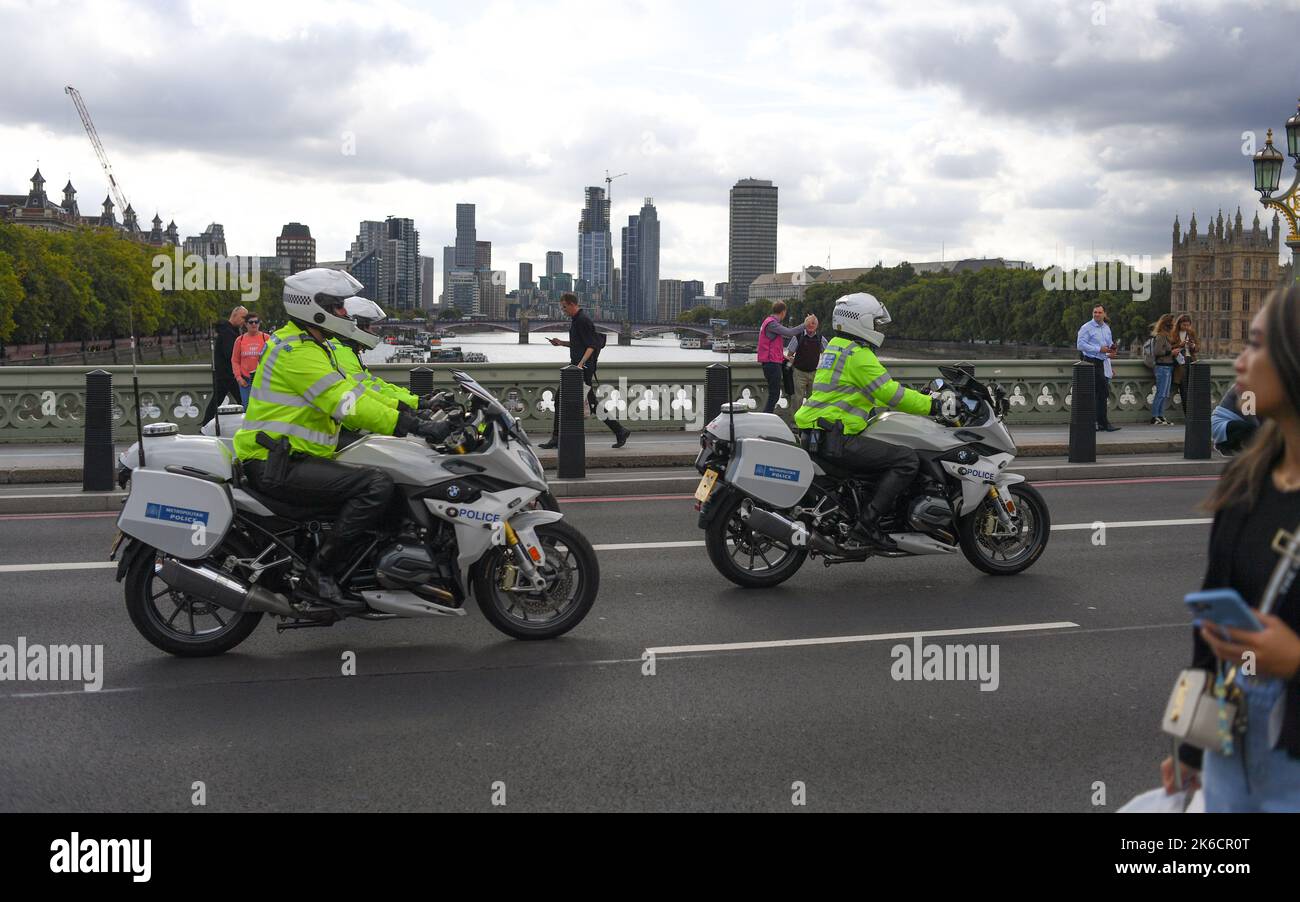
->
xmin=234 ymin=268 xmax=451 ymax=606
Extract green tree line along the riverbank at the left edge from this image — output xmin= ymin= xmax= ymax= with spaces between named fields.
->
xmin=0 ymin=224 xmax=285 ymax=343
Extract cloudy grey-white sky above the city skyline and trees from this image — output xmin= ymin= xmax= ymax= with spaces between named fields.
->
xmin=0 ymin=0 xmax=1300 ymax=289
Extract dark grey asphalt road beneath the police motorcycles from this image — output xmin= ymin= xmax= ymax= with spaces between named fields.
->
xmin=0 ymin=478 xmax=1212 ymax=811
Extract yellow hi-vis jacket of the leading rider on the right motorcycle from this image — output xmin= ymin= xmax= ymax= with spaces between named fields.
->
xmin=794 ymin=335 xmax=930 ymax=435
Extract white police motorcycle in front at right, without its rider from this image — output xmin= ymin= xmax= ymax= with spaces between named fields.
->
xmin=696 ymin=367 xmax=1052 ymax=587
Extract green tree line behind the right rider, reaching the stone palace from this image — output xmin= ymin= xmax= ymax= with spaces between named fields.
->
xmin=679 ymin=264 xmax=1171 ymax=347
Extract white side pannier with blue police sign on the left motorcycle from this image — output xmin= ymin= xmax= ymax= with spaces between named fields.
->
xmin=117 ymin=469 xmax=234 ymax=560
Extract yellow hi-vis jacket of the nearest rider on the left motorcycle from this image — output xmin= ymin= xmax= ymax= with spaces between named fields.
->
xmin=234 ymin=322 xmax=398 ymax=460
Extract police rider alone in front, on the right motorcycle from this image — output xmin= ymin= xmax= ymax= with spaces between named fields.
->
xmin=794 ymin=292 xmax=940 ymax=551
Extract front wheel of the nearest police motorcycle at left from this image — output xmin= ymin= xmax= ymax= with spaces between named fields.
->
xmin=475 ymin=520 xmax=601 ymax=639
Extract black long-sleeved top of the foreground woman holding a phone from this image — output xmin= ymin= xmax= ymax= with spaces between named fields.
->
xmin=1178 ymin=476 xmax=1300 ymax=768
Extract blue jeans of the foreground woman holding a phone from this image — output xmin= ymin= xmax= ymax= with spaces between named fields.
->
xmin=1203 ymin=677 xmax=1300 ymax=812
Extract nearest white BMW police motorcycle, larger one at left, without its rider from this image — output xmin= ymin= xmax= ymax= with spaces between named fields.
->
xmin=112 ymin=370 xmax=601 ymax=656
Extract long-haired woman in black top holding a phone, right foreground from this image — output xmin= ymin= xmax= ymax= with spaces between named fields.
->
xmin=1161 ymin=287 xmax=1300 ymax=811
